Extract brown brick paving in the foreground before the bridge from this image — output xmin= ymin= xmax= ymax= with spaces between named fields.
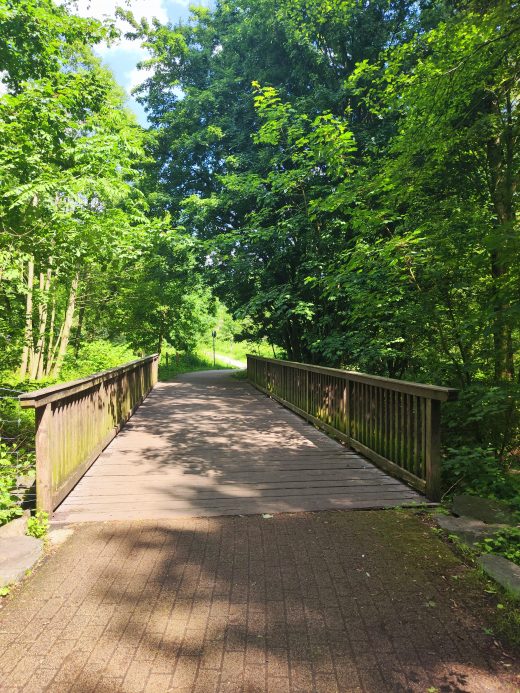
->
xmin=0 ymin=510 xmax=519 ymax=693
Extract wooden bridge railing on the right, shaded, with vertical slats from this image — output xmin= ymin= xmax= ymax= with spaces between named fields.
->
xmin=247 ymin=355 xmax=457 ymax=500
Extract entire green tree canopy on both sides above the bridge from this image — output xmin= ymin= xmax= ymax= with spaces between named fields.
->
xmin=0 ymin=0 xmax=520 ymax=502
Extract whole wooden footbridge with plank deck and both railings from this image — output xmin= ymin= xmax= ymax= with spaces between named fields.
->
xmin=20 ymin=355 xmax=456 ymax=523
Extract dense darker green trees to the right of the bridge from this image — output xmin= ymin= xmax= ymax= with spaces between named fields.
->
xmin=133 ymin=0 xmax=520 ymax=502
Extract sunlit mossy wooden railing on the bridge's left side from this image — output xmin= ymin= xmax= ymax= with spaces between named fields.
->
xmin=19 ymin=354 xmax=159 ymax=513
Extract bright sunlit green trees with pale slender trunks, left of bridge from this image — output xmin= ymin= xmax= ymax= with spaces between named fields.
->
xmin=0 ymin=0 xmax=209 ymax=381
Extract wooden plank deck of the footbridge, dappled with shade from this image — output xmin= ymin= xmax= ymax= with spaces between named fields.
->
xmin=53 ymin=371 xmax=424 ymax=523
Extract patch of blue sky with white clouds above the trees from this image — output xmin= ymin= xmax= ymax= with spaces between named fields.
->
xmin=76 ymin=0 xmax=210 ymax=125
